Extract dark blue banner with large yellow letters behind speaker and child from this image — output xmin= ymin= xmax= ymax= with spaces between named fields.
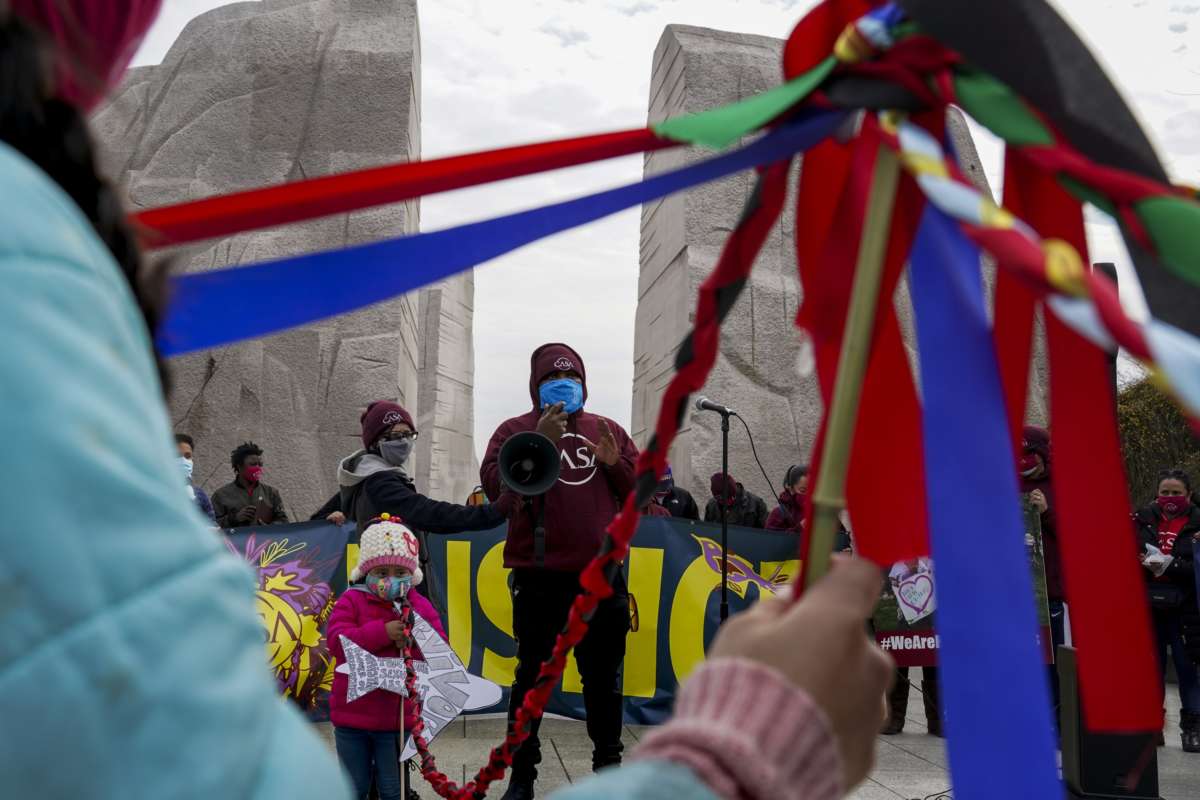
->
xmin=227 ymin=517 xmax=799 ymax=724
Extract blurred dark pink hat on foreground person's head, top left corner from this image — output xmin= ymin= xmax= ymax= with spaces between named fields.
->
xmin=7 ymin=0 xmax=162 ymax=112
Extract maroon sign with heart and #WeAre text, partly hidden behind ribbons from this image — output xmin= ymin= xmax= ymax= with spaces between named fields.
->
xmin=871 ymin=499 xmax=1052 ymax=667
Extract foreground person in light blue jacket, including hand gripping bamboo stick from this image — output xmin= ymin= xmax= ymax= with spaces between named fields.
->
xmin=0 ymin=6 xmax=892 ymax=800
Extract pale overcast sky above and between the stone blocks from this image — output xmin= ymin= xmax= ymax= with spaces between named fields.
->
xmin=136 ymin=0 xmax=1200 ymax=450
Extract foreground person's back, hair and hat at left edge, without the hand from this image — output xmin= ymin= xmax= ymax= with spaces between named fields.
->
xmin=0 ymin=0 xmax=349 ymax=800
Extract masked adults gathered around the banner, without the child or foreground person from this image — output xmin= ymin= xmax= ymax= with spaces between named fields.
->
xmin=166 ymin=367 xmax=1200 ymax=782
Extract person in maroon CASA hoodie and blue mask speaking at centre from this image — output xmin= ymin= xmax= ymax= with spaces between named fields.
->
xmin=479 ymin=343 xmax=637 ymax=800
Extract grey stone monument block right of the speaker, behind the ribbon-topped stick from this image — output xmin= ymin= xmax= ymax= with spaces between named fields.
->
xmin=631 ymin=25 xmax=1044 ymax=507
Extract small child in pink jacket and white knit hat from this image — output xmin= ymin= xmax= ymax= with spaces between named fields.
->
xmin=325 ymin=515 xmax=445 ymax=800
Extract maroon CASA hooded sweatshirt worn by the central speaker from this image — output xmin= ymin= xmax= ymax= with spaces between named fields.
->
xmin=479 ymin=343 xmax=637 ymax=572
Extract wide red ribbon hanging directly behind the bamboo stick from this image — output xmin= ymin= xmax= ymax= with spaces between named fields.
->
xmin=796 ymin=122 xmax=929 ymax=564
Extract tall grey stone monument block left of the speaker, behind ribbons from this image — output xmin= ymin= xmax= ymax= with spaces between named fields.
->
xmin=94 ymin=0 xmax=473 ymax=519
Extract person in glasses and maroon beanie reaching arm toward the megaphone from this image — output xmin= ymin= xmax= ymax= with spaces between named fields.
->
xmin=337 ymin=401 xmax=520 ymax=536
